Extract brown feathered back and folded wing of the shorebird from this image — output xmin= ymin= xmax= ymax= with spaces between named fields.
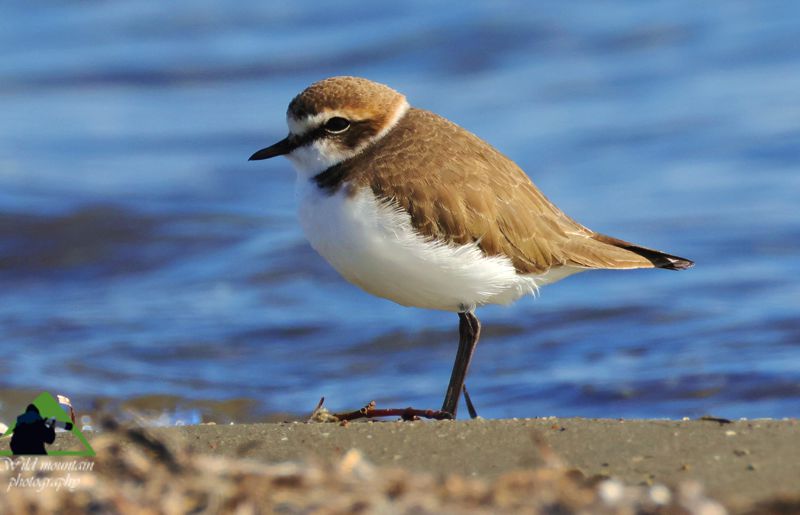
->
xmin=342 ymin=109 xmax=668 ymax=274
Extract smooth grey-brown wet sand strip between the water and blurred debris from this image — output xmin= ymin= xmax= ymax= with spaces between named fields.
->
xmin=45 ymin=418 xmax=800 ymax=508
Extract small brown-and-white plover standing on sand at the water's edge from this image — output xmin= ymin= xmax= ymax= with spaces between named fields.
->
xmin=250 ymin=76 xmax=694 ymax=418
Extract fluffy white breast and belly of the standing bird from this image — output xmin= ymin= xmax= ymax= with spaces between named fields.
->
xmin=297 ymin=176 xmax=549 ymax=311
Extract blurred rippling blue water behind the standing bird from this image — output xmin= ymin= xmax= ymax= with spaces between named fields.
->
xmin=0 ymin=0 xmax=800 ymax=423
